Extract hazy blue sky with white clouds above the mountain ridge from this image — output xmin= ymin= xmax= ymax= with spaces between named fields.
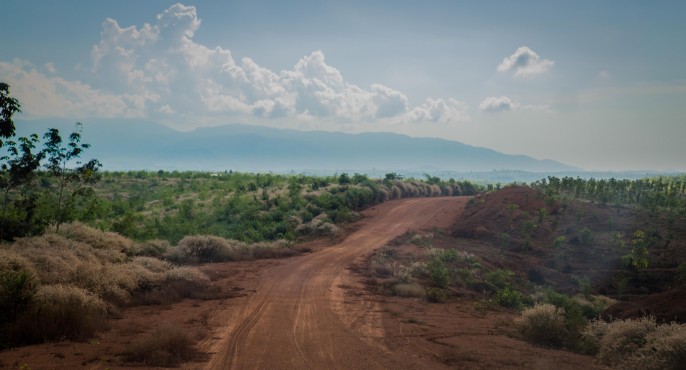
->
xmin=0 ymin=0 xmax=686 ymax=170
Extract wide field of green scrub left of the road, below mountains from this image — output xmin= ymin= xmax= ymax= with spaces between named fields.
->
xmin=70 ymin=171 xmax=481 ymax=244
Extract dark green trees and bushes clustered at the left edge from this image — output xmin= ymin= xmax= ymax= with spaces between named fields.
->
xmin=0 ymin=83 xmax=100 ymax=240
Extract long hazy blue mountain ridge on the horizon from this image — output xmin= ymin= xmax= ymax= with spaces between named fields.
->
xmin=16 ymin=120 xmax=579 ymax=173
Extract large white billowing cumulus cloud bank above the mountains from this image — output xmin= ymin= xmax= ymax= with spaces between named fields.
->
xmin=0 ymin=4 xmax=469 ymax=124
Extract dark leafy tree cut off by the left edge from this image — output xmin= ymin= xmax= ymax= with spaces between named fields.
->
xmin=0 ymin=82 xmax=43 ymax=240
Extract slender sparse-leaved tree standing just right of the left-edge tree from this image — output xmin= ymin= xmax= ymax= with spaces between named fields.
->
xmin=44 ymin=122 xmax=102 ymax=231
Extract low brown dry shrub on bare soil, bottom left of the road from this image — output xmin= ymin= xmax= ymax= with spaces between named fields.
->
xmin=124 ymin=324 xmax=197 ymax=366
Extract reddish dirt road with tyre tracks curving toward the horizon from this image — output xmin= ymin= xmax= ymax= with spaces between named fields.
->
xmin=208 ymin=197 xmax=467 ymax=369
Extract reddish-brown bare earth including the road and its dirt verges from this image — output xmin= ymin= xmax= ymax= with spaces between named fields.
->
xmin=0 ymin=198 xmax=595 ymax=369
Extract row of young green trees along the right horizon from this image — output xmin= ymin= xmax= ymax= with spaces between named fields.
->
xmin=531 ymin=176 xmax=686 ymax=214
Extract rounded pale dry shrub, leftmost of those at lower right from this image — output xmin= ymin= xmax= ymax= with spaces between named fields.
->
xmin=518 ymin=303 xmax=567 ymax=347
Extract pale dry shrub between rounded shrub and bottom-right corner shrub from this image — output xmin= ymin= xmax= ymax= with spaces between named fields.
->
xmin=598 ymin=317 xmax=657 ymax=364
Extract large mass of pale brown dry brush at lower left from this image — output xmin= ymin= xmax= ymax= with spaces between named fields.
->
xmin=0 ymin=224 xmax=212 ymax=344
